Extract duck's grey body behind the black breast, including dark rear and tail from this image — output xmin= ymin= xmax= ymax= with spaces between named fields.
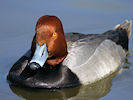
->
xmin=63 ymin=21 xmax=131 ymax=83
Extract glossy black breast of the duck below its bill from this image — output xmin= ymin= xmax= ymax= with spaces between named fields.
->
xmin=7 ymin=56 xmax=80 ymax=88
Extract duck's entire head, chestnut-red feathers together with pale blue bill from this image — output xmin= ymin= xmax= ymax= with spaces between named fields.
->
xmin=28 ymin=15 xmax=67 ymax=70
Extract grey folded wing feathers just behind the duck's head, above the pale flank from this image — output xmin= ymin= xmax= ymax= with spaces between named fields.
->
xmin=63 ymin=34 xmax=106 ymax=67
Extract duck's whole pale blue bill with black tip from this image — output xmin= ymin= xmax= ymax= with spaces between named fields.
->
xmin=28 ymin=43 xmax=48 ymax=70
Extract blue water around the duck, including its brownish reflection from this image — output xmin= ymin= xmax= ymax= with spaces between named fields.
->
xmin=0 ymin=0 xmax=133 ymax=100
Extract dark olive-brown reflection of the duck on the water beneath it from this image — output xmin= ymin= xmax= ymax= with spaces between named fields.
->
xmin=10 ymin=72 xmax=117 ymax=100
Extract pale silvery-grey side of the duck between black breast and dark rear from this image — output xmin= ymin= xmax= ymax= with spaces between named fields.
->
xmin=63 ymin=40 xmax=126 ymax=83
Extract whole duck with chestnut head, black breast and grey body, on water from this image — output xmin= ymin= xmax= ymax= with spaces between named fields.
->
xmin=7 ymin=15 xmax=132 ymax=89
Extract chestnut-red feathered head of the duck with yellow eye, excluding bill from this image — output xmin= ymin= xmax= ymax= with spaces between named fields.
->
xmin=31 ymin=15 xmax=67 ymax=69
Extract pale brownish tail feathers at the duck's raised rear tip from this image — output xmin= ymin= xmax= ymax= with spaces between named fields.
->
xmin=113 ymin=20 xmax=132 ymax=39
